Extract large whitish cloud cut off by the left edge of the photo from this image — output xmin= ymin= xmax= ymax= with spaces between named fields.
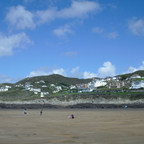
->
xmin=0 ymin=32 xmax=32 ymax=57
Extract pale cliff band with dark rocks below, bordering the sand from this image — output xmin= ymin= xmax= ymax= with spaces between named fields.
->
xmin=0 ymin=98 xmax=144 ymax=109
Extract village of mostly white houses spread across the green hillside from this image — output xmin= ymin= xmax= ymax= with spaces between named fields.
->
xmin=0 ymin=74 xmax=144 ymax=97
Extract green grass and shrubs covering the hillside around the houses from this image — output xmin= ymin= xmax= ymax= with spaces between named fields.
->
xmin=0 ymin=71 xmax=144 ymax=101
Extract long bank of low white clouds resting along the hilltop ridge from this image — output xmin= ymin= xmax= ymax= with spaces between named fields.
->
xmin=28 ymin=61 xmax=116 ymax=79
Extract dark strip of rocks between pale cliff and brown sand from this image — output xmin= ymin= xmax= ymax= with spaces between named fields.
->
xmin=0 ymin=103 xmax=144 ymax=109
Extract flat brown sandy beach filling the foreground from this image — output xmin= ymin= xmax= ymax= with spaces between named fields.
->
xmin=0 ymin=109 xmax=144 ymax=144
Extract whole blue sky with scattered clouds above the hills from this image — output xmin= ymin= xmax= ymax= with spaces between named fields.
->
xmin=0 ymin=0 xmax=144 ymax=83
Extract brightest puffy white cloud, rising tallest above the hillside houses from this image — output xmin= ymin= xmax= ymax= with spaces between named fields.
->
xmin=98 ymin=61 xmax=116 ymax=77
